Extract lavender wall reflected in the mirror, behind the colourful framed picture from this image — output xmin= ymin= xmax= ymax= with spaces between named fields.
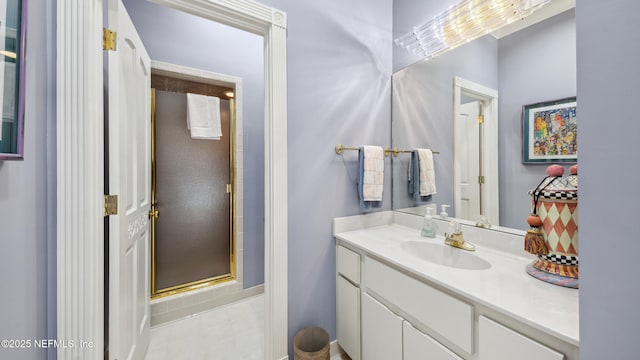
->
xmin=498 ymin=10 xmax=583 ymax=229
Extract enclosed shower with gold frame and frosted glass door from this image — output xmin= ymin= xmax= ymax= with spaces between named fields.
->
xmin=151 ymin=69 xmax=237 ymax=298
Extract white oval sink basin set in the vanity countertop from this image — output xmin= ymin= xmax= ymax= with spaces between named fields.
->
xmin=400 ymin=241 xmax=491 ymax=270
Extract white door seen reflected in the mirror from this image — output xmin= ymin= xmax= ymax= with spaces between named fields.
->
xmin=455 ymin=101 xmax=481 ymax=220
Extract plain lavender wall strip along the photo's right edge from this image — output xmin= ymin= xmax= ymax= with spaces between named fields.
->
xmin=576 ymin=0 xmax=640 ymax=360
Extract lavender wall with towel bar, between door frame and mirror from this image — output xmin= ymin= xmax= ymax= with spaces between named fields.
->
xmin=263 ymin=0 xmax=392 ymax=354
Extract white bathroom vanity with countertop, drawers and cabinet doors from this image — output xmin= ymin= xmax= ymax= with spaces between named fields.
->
xmin=333 ymin=211 xmax=579 ymax=360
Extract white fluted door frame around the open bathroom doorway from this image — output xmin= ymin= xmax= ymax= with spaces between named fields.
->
xmin=56 ymin=0 xmax=288 ymax=360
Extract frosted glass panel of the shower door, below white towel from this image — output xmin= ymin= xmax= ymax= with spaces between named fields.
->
xmin=154 ymin=90 xmax=233 ymax=293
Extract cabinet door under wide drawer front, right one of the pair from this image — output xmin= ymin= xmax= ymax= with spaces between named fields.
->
xmin=402 ymin=321 xmax=462 ymax=360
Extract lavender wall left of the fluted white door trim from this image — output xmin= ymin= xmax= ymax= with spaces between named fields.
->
xmin=0 ymin=1 xmax=56 ymax=360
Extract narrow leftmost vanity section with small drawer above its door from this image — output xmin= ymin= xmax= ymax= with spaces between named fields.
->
xmin=336 ymin=245 xmax=361 ymax=360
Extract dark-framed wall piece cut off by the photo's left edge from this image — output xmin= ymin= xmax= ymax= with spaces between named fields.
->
xmin=0 ymin=0 xmax=26 ymax=160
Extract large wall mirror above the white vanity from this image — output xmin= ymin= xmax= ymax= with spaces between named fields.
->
xmin=392 ymin=0 xmax=576 ymax=229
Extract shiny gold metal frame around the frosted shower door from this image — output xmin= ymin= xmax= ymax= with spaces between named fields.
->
xmin=149 ymin=88 xmax=236 ymax=299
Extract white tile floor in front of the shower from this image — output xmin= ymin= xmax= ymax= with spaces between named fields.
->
xmin=145 ymin=294 xmax=264 ymax=360
